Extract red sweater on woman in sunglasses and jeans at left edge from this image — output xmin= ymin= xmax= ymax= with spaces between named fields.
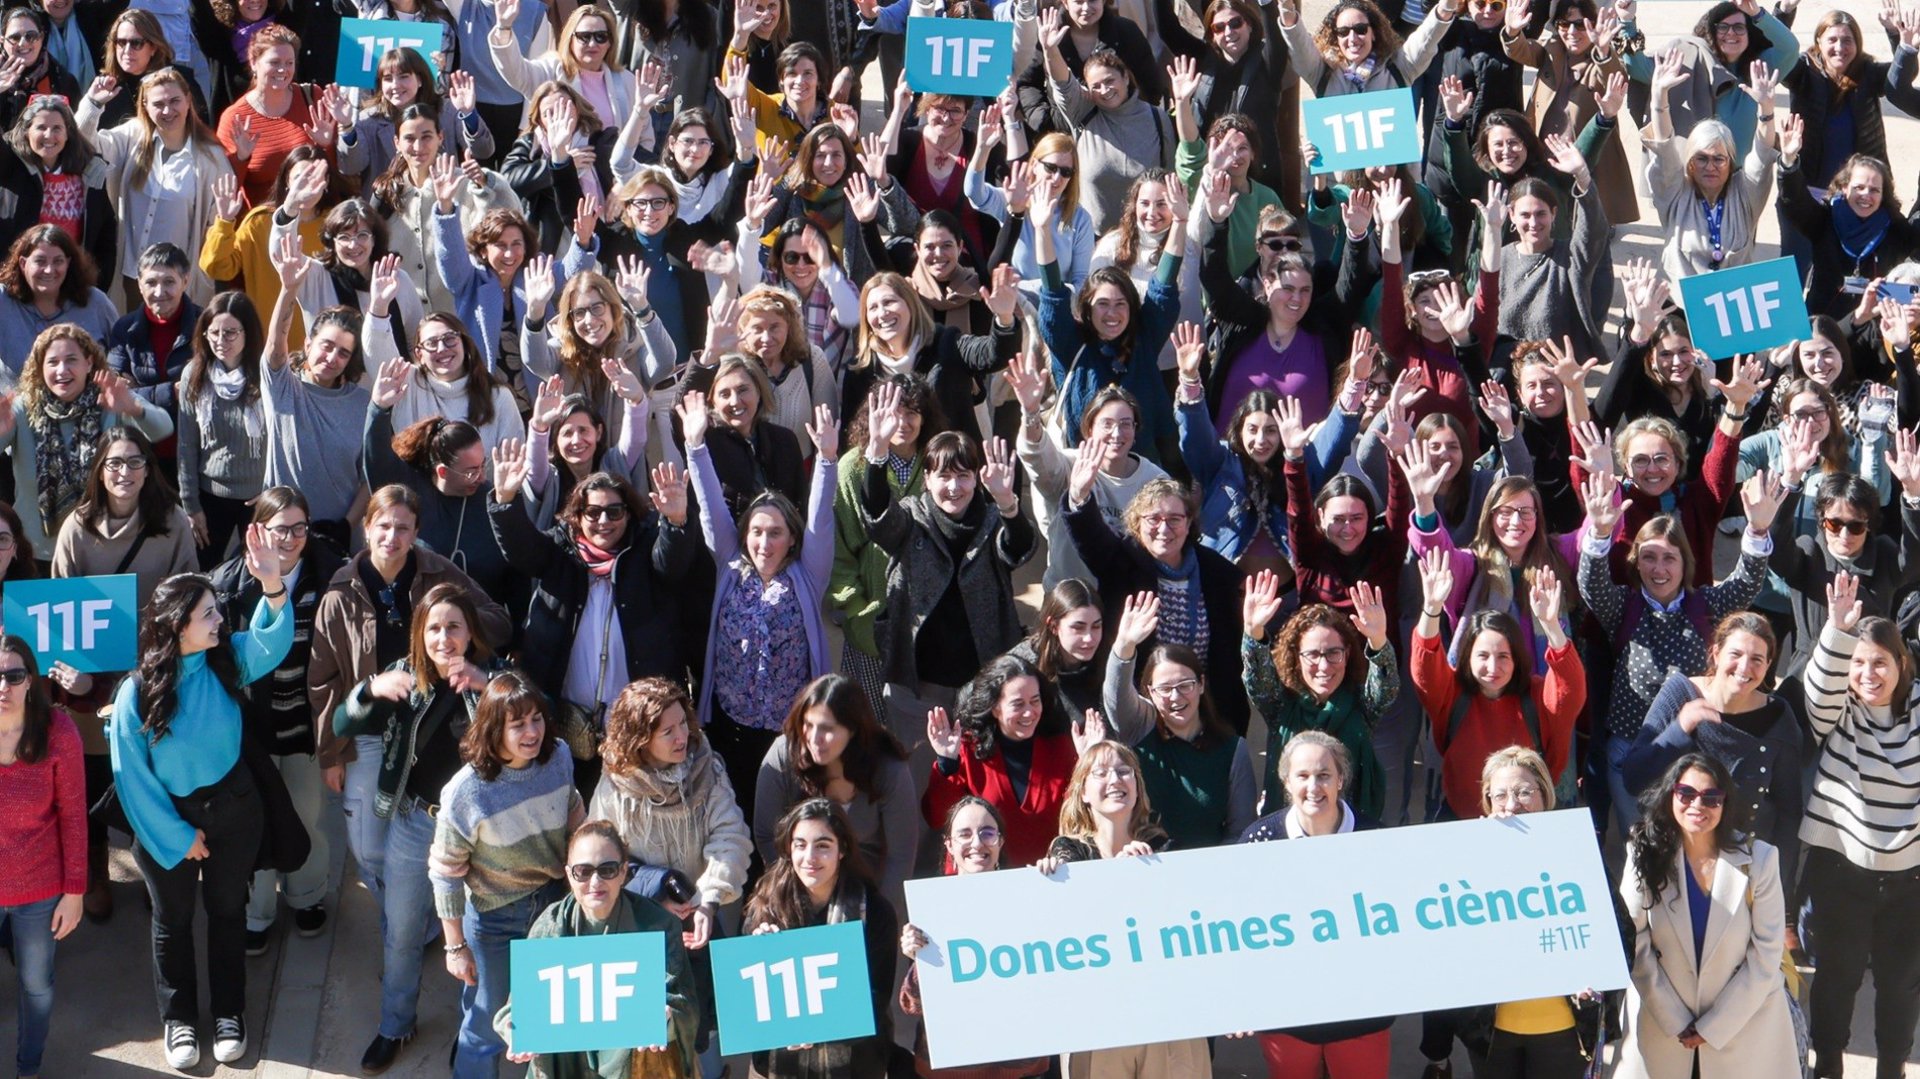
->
xmin=0 ymin=708 xmax=86 ymax=906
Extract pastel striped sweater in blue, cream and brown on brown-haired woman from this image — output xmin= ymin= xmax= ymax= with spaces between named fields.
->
xmin=426 ymin=745 xmax=586 ymax=918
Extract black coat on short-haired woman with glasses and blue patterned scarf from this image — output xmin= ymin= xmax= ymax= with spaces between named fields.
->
xmin=1064 ymin=499 xmax=1252 ymax=737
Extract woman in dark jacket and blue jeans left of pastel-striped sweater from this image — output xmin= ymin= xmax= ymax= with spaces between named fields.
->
xmin=332 ymin=584 xmax=493 ymax=1075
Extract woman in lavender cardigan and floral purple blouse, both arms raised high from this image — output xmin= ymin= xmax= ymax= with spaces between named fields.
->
xmin=691 ymin=392 xmax=839 ymax=816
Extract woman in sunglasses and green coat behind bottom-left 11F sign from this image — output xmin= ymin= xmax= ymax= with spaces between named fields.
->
xmin=493 ymin=820 xmax=699 ymax=1079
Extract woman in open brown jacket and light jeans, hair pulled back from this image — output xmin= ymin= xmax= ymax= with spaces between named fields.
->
xmin=307 ymin=484 xmax=513 ymax=925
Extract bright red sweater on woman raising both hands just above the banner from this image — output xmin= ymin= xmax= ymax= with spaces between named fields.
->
xmin=1407 ymin=634 xmax=1586 ymax=820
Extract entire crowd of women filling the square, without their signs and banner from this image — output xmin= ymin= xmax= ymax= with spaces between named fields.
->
xmin=0 ymin=0 xmax=1920 ymax=1079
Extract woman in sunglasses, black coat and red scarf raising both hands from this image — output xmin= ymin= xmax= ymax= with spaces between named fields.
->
xmin=488 ymin=433 xmax=699 ymax=789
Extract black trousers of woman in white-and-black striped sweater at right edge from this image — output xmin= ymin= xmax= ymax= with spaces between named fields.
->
xmin=1803 ymin=847 xmax=1920 ymax=1079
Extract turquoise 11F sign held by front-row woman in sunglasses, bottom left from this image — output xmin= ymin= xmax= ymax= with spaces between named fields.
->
xmin=507 ymin=933 xmax=666 ymax=1052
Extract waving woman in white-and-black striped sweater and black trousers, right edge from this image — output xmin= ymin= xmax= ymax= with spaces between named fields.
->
xmin=1797 ymin=570 xmax=1920 ymax=1079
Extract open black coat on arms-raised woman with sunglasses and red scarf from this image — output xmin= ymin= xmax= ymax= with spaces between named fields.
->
xmin=488 ymin=493 xmax=707 ymax=701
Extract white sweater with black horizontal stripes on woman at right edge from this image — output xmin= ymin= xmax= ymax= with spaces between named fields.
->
xmin=1801 ymin=622 xmax=1920 ymax=874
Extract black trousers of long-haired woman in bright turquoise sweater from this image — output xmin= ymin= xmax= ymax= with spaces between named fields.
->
xmin=132 ymin=762 xmax=265 ymax=1023
